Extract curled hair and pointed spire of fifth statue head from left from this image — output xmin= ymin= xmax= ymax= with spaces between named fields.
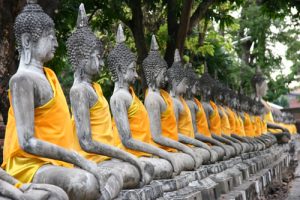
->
xmin=167 ymin=49 xmax=186 ymax=85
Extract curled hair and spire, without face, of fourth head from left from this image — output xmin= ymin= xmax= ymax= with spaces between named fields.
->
xmin=142 ymin=35 xmax=168 ymax=86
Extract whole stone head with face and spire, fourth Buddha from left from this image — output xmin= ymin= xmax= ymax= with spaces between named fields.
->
xmin=143 ymin=35 xmax=168 ymax=90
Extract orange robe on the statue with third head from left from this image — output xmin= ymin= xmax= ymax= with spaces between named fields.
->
xmin=113 ymin=87 xmax=155 ymax=157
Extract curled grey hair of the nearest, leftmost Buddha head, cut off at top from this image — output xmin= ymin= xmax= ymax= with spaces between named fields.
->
xmin=14 ymin=0 xmax=54 ymax=54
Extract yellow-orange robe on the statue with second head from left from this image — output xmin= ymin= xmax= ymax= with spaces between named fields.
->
xmin=72 ymin=83 xmax=119 ymax=163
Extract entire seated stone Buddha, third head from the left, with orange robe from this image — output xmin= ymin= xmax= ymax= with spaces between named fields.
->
xmin=108 ymin=25 xmax=180 ymax=179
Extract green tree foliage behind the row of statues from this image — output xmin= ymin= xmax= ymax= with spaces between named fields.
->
xmin=42 ymin=0 xmax=300 ymax=101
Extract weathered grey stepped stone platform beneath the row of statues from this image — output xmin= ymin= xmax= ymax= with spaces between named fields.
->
xmin=117 ymin=145 xmax=290 ymax=200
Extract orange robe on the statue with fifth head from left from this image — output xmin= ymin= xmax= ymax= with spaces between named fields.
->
xmin=178 ymin=97 xmax=195 ymax=138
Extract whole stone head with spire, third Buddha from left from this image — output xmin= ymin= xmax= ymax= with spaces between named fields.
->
xmin=107 ymin=24 xmax=138 ymax=87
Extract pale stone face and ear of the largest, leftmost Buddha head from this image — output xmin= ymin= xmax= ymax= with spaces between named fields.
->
xmin=30 ymin=28 xmax=58 ymax=63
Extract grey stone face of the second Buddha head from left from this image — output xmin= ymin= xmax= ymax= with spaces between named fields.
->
xmin=84 ymin=47 xmax=104 ymax=75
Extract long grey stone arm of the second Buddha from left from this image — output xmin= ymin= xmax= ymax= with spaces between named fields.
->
xmin=70 ymin=88 xmax=144 ymax=184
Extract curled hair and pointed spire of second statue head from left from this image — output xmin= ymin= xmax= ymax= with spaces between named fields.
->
xmin=67 ymin=4 xmax=103 ymax=70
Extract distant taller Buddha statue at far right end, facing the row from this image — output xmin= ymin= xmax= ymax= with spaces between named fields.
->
xmin=251 ymin=67 xmax=289 ymax=143
